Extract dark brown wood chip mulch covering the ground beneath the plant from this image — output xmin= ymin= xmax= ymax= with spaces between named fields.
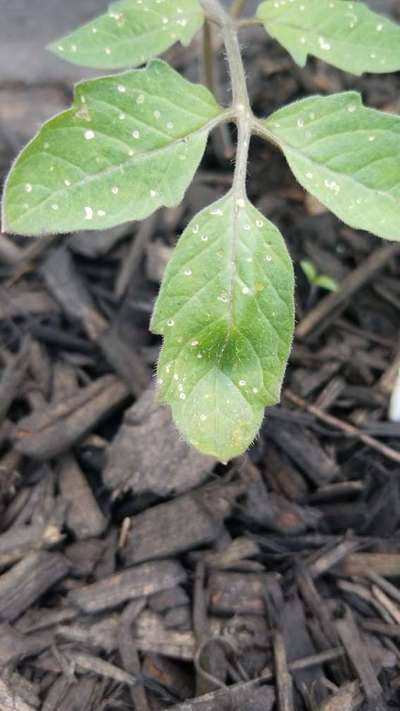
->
xmin=0 ymin=19 xmax=400 ymax=711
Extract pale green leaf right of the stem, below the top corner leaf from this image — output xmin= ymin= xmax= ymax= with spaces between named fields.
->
xmin=262 ymin=92 xmax=400 ymax=241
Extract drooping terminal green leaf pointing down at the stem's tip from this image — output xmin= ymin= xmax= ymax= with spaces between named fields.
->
xmin=151 ymin=191 xmax=294 ymax=461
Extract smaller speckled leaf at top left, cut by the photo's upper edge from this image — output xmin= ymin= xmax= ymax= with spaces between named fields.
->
xmin=49 ymin=0 xmax=204 ymax=69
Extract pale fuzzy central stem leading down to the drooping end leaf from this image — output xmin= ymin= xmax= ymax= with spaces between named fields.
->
xmin=201 ymin=0 xmax=253 ymax=200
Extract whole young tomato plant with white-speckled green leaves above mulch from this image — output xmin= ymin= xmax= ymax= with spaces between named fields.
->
xmin=3 ymin=0 xmax=400 ymax=461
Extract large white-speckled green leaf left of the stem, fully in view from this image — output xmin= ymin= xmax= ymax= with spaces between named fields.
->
xmin=3 ymin=60 xmax=224 ymax=235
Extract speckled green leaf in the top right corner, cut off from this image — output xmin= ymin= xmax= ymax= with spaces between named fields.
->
xmin=257 ymin=0 xmax=400 ymax=74
